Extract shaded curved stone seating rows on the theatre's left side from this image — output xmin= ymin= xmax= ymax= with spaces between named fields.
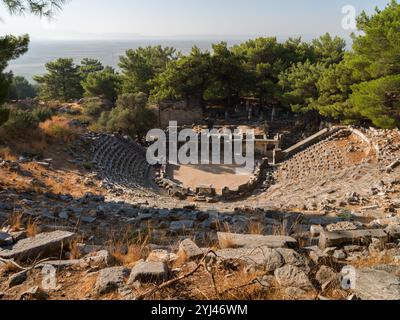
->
xmin=92 ymin=134 xmax=155 ymax=191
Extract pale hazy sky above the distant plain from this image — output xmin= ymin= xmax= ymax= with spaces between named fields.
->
xmin=0 ymin=0 xmax=394 ymax=39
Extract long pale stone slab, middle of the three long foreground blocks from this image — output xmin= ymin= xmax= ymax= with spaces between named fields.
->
xmin=217 ymin=232 xmax=297 ymax=249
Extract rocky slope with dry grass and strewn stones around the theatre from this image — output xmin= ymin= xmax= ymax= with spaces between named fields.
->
xmin=0 ymin=122 xmax=400 ymax=300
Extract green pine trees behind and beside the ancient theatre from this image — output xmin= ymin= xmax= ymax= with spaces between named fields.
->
xmin=0 ymin=1 xmax=400 ymax=140
